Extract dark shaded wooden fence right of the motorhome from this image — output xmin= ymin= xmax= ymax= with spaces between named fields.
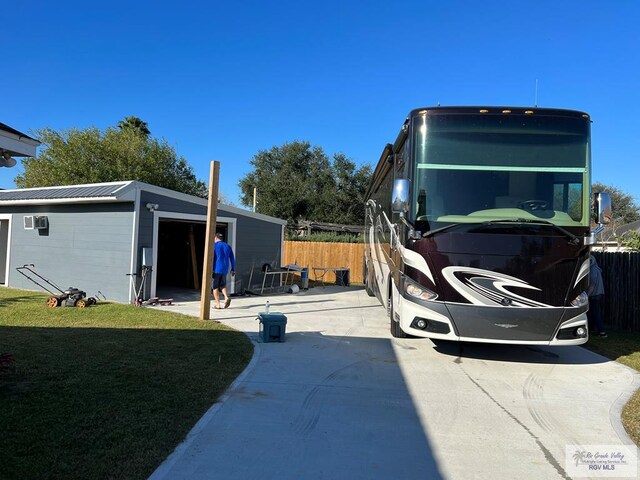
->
xmin=593 ymin=252 xmax=640 ymax=333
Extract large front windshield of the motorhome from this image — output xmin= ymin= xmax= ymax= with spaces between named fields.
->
xmin=410 ymin=114 xmax=590 ymax=230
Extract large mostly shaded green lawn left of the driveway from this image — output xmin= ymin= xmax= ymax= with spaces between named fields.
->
xmin=0 ymin=288 xmax=253 ymax=480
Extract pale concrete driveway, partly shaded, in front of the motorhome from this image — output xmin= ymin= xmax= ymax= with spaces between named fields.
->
xmin=151 ymin=287 xmax=640 ymax=480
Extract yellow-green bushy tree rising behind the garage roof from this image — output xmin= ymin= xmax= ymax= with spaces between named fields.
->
xmin=14 ymin=117 xmax=208 ymax=198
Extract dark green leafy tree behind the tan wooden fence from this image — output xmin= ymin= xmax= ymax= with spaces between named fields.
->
xmin=239 ymin=141 xmax=371 ymax=225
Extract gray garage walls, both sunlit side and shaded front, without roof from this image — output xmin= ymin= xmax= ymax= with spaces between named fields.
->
xmin=0 ymin=189 xmax=282 ymax=302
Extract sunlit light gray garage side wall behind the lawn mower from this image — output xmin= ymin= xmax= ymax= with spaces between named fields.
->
xmin=0 ymin=203 xmax=133 ymax=302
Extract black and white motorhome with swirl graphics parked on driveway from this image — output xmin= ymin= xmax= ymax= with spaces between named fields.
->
xmin=364 ymin=106 xmax=611 ymax=345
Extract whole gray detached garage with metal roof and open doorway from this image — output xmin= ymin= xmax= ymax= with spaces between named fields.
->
xmin=0 ymin=181 xmax=286 ymax=303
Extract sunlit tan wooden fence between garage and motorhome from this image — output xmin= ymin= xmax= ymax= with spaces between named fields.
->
xmin=282 ymin=241 xmax=364 ymax=284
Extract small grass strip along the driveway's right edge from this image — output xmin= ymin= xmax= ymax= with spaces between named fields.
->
xmin=585 ymin=332 xmax=640 ymax=446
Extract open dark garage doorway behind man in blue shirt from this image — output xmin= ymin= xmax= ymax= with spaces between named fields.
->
xmin=150 ymin=212 xmax=236 ymax=298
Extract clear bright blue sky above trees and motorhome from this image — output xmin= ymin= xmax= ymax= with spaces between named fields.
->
xmin=0 ymin=0 xmax=640 ymax=205
